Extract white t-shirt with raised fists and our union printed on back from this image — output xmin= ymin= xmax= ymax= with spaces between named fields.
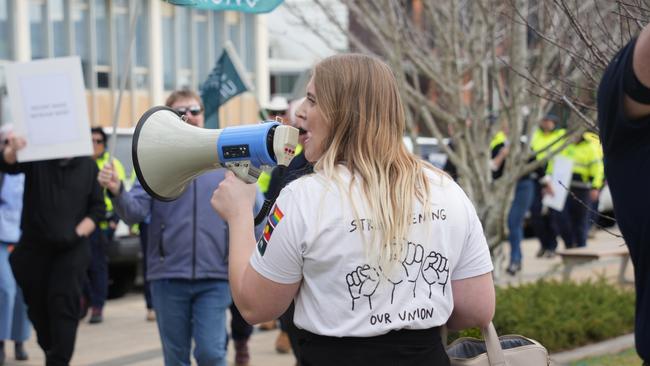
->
xmin=251 ymin=168 xmax=493 ymax=337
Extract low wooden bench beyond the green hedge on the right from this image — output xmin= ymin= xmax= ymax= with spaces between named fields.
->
xmin=557 ymin=245 xmax=630 ymax=284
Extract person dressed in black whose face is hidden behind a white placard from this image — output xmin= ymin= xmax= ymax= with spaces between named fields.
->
xmin=0 ymin=134 xmax=105 ymax=366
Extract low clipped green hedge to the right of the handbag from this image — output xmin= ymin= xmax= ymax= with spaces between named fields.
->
xmin=450 ymin=279 xmax=634 ymax=352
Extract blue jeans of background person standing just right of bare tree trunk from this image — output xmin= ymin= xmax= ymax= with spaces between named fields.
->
xmin=508 ymin=179 xmax=535 ymax=263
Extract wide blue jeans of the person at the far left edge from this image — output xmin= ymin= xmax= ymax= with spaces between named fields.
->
xmin=0 ymin=243 xmax=32 ymax=342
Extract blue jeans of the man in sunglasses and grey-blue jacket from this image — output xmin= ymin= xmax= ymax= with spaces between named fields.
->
xmin=151 ymin=279 xmax=232 ymax=366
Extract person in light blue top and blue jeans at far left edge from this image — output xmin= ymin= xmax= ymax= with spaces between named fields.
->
xmin=0 ymin=125 xmax=31 ymax=365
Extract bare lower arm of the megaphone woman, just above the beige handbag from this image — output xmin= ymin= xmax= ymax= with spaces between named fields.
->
xmin=447 ymin=272 xmax=495 ymax=330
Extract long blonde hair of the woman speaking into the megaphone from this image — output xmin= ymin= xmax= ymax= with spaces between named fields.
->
xmin=313 ymin=54 xmax=434 ymax=270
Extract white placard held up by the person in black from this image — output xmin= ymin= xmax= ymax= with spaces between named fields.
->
xmin=5 ymin=56 xmax=93 ymax=162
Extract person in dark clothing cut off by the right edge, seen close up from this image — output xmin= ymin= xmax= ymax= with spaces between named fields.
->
xmin=598 ymin=25 xmax=650 ymax=365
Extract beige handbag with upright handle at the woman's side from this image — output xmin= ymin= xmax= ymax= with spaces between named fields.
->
xmin=447 ymin=323 xmax=550 ymax=366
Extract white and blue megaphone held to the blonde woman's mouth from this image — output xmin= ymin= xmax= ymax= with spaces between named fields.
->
xmin=131 ymin=107 xmax=298 ymax=223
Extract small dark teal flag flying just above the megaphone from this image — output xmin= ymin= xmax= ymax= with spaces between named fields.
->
xmin=201 ymin=42 xmax=253 ymax=128
